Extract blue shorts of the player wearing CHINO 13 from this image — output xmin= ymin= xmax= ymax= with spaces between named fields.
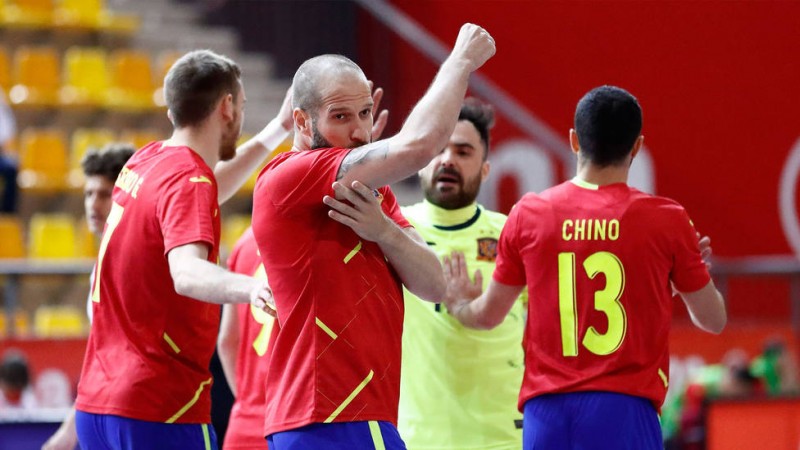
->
xmin=522 ymin=392 xmax=664 ymax=450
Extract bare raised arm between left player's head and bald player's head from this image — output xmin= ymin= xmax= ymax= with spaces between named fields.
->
xmin=214 ymin=87 xmax=294 ymax=204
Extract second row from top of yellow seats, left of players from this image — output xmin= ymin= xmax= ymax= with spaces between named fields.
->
xmin=0 ymin=46 xmax=178 ymax=112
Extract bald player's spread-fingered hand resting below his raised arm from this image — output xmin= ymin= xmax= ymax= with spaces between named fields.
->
xmin=322 ymin=181 xmax=394 ymax=242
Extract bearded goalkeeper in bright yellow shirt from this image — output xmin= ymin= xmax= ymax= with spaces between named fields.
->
xmin=398 ymin=99 xmax=527 ymax=450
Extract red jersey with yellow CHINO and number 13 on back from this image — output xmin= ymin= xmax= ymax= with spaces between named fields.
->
xmin=494 ymin=181 xmax=710 ymax=409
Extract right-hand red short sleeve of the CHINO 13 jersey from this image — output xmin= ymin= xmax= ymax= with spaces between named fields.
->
xmin=670 ymin=208 xmax=711 ymax=292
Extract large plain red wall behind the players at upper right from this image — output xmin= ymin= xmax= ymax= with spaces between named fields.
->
xmin=359 ymin=0 xmax=800 ymax=328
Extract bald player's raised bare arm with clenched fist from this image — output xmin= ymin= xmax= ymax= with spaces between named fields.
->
xmin=337 ymin=24 xmax=495 ymax=192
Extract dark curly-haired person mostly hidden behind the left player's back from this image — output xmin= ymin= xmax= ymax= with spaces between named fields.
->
xmin=42 ymin=143 xmax=136 ymax=450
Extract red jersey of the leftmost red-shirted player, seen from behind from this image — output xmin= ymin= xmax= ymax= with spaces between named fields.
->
xmin=75 ymin=142 xmax=220 ymax=423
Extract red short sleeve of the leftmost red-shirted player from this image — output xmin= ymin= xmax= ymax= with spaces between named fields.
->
xmin=156 ymin=167 xmax=219 ymax=255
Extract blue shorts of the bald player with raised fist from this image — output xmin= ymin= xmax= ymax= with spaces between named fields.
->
xmin=267 ymin=421 xmax=406 ymax=450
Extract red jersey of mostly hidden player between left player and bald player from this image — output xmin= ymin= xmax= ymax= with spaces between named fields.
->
xmin=222 ymin=228 xmax=277 ymax=450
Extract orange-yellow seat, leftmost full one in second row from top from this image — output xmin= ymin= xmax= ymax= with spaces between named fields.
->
xmin=8 ymin=47 xmax=61 ymax=106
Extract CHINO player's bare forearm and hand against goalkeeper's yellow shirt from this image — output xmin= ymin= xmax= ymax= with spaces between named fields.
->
xmin=443 ymin=252 xmax=525 ymax=330
